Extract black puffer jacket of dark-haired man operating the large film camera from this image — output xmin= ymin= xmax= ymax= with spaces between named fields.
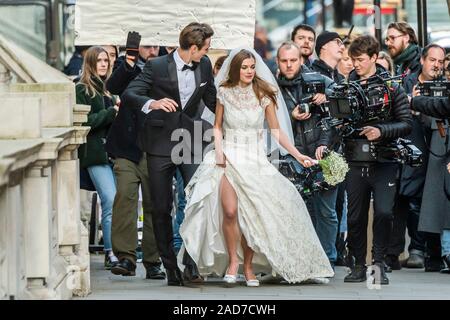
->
xmin=349 ymin=64 xmax=412 ymax=140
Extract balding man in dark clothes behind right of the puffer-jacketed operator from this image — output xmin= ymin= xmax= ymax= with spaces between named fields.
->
xmin=386 ymin=44 xmax=445 ymax=271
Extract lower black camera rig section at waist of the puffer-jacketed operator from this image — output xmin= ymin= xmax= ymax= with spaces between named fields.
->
xmin=344 ymin=138 xmax=423 ymax=167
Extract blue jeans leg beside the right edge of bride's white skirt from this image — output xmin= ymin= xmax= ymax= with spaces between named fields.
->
xmin=308 ymin=189 xmax=338 ymax=263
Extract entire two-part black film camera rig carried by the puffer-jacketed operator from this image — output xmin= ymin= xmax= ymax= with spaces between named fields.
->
xmin=321 ymin=74 xmax=422 ymax=167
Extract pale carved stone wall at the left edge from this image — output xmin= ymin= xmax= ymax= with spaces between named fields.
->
xmin=0 ymin=42 xmax=90 ymax=299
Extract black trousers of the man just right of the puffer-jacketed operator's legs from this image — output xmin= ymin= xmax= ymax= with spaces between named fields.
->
xmin=387 ymin=195 xmax=425 ymax=257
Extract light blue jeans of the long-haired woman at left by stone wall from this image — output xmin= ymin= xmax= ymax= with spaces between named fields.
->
xmin=87 ymin=164 xmax=116 ymax=251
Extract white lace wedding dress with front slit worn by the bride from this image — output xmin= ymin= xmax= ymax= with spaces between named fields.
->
xmin=178 ymin=86 xmax=334 ymax=283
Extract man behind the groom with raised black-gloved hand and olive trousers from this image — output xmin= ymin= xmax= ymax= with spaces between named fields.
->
xmin=105 ymin=32 xmax=166 ymax=280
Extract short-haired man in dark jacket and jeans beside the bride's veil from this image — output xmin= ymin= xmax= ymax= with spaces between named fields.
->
xmin=277 ymin=41 xmax=338 ymax=266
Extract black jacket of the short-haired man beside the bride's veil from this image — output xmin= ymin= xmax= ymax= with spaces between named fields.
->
xmin=277 ymin=66 xmax=329 ymax=157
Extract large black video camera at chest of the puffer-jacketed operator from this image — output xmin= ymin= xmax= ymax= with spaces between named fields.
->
xmin=321 ymin=75 xmax=400 ymax=137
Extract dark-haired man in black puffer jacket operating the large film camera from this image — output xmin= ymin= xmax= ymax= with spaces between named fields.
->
xmin=344 ymin=35 xmax=412 ymax=284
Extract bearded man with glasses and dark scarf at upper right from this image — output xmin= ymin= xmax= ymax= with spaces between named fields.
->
xmin=385 ymin=22 xmax=421 ymax=75
